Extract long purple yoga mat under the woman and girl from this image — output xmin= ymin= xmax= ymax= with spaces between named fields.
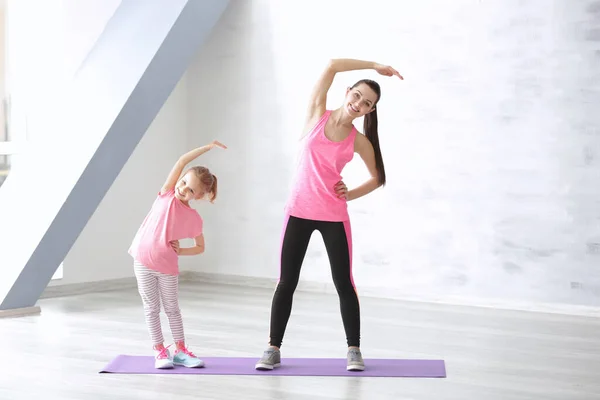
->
xmin=100 ymin=355 xmax=446 ymax=378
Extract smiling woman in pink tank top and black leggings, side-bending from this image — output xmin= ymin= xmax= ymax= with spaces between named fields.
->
xmin=256 ymin=59 xmax=403 ymax=371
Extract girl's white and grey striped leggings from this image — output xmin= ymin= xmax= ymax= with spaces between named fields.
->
xmin=133 ymin=261 xmax=184 ymax=345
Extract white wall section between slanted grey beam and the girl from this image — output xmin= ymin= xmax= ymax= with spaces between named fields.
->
xmin=52 ymin=76 xmax=187 ymax=286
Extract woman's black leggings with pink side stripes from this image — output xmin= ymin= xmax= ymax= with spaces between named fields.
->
xmin=270 ymin=216 xmax=360 ymax=347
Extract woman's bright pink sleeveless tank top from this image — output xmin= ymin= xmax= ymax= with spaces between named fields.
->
xmin=286 ymin=110 xmax=357 ymax=222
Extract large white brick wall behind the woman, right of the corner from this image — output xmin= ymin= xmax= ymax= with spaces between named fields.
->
xmin=184 ymin=0 xmax=600 ymax=305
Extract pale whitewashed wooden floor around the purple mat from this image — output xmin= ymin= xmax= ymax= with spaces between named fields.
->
xmin=0 ymin=284 xmax=600 ymax=400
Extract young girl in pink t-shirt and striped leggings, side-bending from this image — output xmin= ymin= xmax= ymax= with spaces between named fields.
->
xmin=129 ymin=140 xmax=227 ymax=368
